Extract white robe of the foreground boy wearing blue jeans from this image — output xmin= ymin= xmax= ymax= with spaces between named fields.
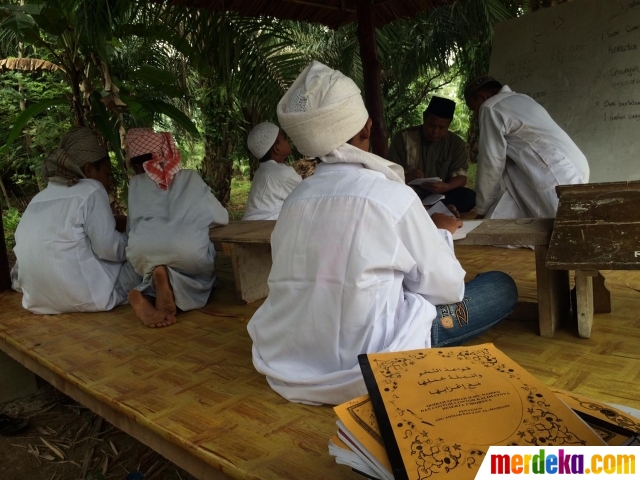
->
xmin=248 ymin=163 xmax=465 ymax=404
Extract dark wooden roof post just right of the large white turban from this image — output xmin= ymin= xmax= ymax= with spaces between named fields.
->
xmin=356 ymin=0 xmax=389 ymax=158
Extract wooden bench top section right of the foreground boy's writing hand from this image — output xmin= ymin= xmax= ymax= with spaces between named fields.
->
xmin=455 ymin=218 xmax=553 ymax=246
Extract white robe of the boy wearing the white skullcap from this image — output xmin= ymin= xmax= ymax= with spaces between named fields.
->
xmin=242 ymin=160 xmax=302 ymax=220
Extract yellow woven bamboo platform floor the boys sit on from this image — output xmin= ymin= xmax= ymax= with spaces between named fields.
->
xmin=0 ymin=247 xmax=640 ymax=479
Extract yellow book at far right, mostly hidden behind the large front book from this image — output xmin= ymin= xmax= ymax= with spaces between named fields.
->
xmin=551 ymin=388 xmax=640 ymax=446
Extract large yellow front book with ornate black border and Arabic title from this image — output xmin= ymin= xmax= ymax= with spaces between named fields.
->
xmin=358 ymin=344 xmax=606 ymax=480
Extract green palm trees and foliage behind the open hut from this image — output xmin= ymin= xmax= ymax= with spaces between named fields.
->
xmin=0 ymin=0 xmax=527 ymax=210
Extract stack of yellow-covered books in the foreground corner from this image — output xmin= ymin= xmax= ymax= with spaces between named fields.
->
xmin=330 ymin=344 xmax=640 ymax=480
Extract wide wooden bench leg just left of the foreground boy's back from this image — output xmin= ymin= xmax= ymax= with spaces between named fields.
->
xmin=222 ymin=243 xmax=272 ymax=303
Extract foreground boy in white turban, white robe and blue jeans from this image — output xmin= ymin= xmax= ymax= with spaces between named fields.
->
xmin=248 ymin=62 xmax=517 ymax=404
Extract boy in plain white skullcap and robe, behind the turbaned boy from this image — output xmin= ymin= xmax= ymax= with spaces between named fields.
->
xmin=242 ymin=122 xmax=302 ymax=220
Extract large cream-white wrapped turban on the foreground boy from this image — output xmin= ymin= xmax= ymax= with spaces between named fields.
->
xmin=277 ymin=61 xmax=369 ymax=157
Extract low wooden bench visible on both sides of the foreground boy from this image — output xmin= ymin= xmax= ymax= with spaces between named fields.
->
xmin=210 ymin=219 xmax=569 ymax=337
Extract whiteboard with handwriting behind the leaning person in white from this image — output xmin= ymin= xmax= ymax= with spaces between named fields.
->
xmin=489 ymin=0 xmax=640 ymax=182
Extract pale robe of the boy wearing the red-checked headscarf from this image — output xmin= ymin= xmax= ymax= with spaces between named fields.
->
xmin=127 ymin=170 xmax=229 ymax=311
